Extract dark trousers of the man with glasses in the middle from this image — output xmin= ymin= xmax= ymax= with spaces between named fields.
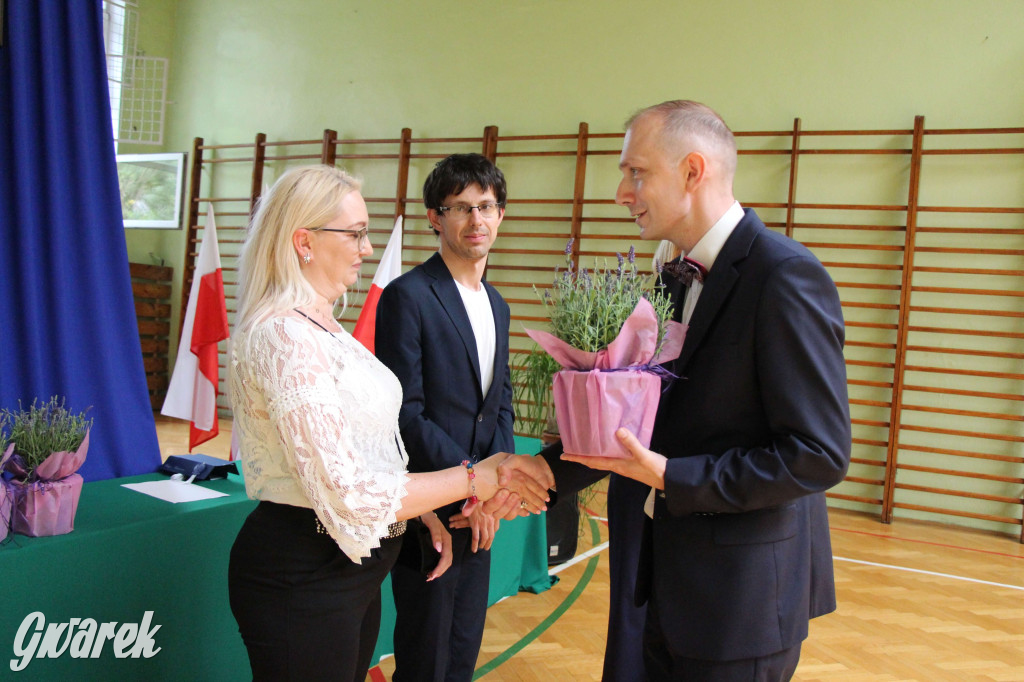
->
xmin=391 ymin=528 xmax=490 ymax=682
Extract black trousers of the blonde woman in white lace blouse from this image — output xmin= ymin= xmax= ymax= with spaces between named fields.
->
xmin=227 ymin=502 xmax=401 ymax=682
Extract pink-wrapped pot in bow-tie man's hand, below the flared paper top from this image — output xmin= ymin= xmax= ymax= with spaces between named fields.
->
xmin=552 ymin=369 xmax=662 ymax=458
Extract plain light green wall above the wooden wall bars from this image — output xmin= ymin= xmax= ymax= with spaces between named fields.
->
xmin=128 ymin=0 xmax=1024 ymax=339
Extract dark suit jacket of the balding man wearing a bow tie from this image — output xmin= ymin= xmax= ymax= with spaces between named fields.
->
xmin=547 ymin=210 xmax=851 ymax=660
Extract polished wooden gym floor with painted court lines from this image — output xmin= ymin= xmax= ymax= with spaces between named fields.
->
xmin=151 ymin=417 xmax=1024 ymax=682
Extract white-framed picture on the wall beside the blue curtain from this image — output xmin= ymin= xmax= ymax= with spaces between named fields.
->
xmin=118 ymin=153 xmax=185 ymax=229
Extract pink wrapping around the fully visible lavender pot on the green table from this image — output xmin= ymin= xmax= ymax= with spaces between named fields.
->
xmin=6 ymin=433 xmax=89 ymax=538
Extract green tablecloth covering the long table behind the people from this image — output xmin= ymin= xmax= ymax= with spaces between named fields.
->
xmin=0 ymin=454 xmax=550 ymax=682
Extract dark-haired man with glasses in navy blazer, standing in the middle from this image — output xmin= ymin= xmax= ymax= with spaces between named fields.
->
xmin=375 ymin=154 xmax=514 ymax=682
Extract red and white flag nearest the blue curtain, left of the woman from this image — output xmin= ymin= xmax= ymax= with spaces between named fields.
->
xmin=160 ymin=206 xmax=228 ymax=452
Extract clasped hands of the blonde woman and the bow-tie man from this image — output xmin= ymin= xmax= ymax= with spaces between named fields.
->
xmin=463 ymin=453 xmax=555 ymax=520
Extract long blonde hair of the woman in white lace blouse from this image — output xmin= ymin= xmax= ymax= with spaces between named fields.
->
xmin=236 ymin=166 xmax=360 ymax=330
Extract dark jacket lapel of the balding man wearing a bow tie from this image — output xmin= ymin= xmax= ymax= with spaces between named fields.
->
xmin=675 ymin=209 xmax=765 ymax=376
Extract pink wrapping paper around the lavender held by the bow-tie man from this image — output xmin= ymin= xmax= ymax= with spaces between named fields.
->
xmin=526 ymin=298 xmax=686 ymax=458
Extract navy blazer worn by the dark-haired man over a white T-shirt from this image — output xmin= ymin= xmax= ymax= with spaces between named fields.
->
xmin=374 ymin=254 xmax=515 ymax=518
